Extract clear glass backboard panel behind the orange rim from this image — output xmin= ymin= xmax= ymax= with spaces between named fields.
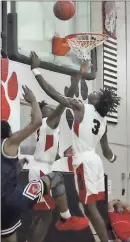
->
xmin=8 ymin=0 xmax=96 ymax=79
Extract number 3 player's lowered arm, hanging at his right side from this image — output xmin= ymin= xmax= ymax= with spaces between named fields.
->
xmin=100 ymin=127 xmax=117 ymax=163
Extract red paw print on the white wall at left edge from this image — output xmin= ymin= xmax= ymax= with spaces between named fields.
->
xmin=1 ymin=58 xmax=18 ymax=120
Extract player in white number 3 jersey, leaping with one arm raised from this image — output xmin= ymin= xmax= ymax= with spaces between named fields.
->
xmin=30 ymin=53 xmax=120 ymax=242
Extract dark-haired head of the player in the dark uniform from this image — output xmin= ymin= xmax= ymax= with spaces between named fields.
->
xmin=1 ymin=120 xmax=12 ymax=139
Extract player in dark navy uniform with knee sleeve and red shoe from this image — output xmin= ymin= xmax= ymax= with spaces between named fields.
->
xmin=1 ymin=84 xmax=88 ymax=242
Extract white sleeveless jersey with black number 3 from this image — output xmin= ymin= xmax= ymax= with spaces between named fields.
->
xmin=72 ymin=104 xmax=106 ymax=156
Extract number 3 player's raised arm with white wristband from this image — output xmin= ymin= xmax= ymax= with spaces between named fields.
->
xmin=31 ymin=52 xmax=81 ymax=109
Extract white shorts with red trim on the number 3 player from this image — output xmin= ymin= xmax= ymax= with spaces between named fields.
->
xmin=74 ymin=152 xmax=105 ymax=204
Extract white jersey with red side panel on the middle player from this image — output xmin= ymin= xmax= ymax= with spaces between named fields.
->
xmin=34 ymin=118 xmax=59 ymax=163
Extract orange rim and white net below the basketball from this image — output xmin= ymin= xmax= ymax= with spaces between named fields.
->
xmin=65 ymin=33 xmax=108 ymax=62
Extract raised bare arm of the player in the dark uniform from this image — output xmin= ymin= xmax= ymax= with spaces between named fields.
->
xmin=4 ymin=86 xmax=42 ymax=156
